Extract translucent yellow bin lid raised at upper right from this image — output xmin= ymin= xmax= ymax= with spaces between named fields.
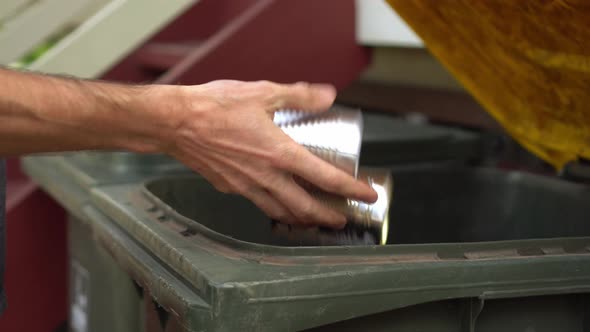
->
xmin=387 ymin=0 xmax=590 ymax=169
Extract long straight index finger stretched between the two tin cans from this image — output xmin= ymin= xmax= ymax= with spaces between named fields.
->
xmin=280 ymin=144 xmax=377 ymax=203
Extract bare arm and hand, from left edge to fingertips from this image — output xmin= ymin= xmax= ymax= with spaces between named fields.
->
xmin=0 ymin=69 xmax=377 ymax=226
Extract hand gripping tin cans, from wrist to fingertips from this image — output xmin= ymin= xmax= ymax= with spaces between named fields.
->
xmin=160 ymin=81 xmax=377 ymax=228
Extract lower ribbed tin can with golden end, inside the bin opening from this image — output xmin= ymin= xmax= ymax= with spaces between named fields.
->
xmin=273 ymin=168 xmax=393 ymax=245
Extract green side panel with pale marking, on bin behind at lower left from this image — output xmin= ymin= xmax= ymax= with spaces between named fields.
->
xmin=68 ymin=218 xmax=143 ymax=332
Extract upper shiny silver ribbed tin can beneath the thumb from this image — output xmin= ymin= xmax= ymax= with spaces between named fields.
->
xmin=274 ymin=107 xmax=363 ymax=177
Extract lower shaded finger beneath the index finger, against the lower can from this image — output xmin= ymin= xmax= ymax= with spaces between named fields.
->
xmin=269 ymin=175 xmax=346 ymax=228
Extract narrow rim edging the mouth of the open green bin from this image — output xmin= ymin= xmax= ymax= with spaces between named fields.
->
xmin=139 ymin=166 xmax=590 ymax=264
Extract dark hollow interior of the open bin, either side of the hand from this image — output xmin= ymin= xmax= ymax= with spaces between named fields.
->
xmin=146 ymin=168 xmax=590 ymax=245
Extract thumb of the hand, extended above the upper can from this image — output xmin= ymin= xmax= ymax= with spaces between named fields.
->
xmin=271 ymin=82 xmax=336 ymax=112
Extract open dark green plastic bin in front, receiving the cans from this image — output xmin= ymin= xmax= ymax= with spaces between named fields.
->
xmin=82 ymin=168 xmax=590 ymax=331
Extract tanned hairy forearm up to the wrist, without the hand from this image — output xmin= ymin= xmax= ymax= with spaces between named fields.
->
xmin=0 ymin=68 xmax=173 ymax=156
